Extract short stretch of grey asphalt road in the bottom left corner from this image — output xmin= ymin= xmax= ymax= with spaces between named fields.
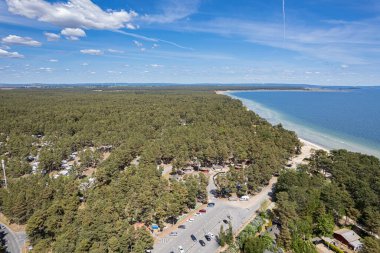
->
xmin=0 ymin=224 xmax=26 ymax=253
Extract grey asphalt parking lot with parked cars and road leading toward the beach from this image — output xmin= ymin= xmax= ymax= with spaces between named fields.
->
xmin=152 ymin=174 xmax=276 ymax=253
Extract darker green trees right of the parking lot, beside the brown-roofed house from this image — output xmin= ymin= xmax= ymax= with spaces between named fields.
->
xmin=275 ymin=150 xmax=380 ymax=252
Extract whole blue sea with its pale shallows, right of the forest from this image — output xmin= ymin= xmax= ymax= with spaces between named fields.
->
xmin=227 ymin=87 xmax=380 ymax=157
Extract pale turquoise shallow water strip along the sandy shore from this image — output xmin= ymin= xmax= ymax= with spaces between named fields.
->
xmin=217 ymin=91 xmax=380 ymax=157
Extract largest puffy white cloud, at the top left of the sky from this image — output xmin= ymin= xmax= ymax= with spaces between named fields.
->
xmin=6 ymin=0 xmax=137 ymax=30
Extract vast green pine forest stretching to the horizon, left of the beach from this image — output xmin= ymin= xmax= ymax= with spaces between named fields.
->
xmin=0 ymin=89 xmax=300 ymax=253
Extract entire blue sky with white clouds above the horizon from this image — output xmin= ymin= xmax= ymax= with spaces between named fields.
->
xmin=0 ymin=0 xmax=380 ymax=85
